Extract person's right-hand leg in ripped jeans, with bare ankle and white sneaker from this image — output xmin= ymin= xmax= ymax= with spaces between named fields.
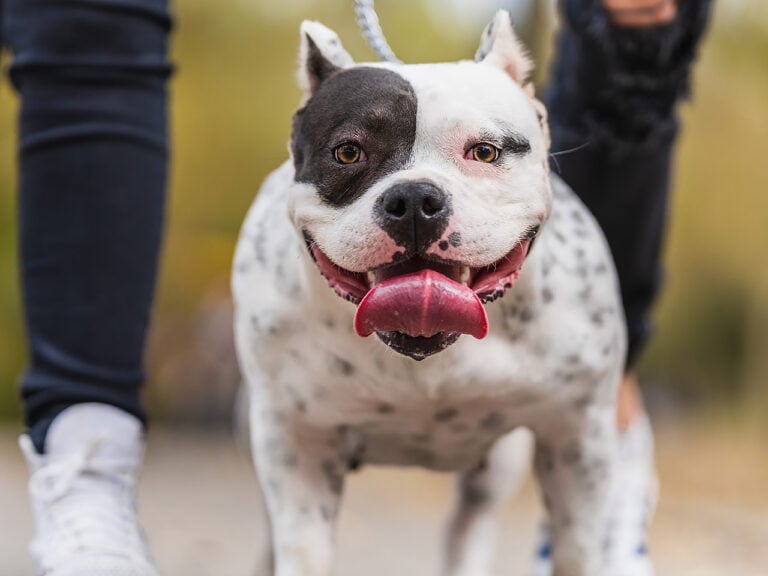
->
xmin=535 ymin=0 xmax=710 ymax=576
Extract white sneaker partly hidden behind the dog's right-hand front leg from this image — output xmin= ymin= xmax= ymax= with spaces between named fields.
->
xmin=532 ymin=414 xmax=659 ymax=576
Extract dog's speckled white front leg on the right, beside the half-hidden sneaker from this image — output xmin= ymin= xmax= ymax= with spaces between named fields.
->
xmin=535 ymin=409 xmax=616 ymax=576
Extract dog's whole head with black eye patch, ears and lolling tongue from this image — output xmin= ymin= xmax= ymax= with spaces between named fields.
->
xmin=289 ymin=12 xmax=551 ymax=359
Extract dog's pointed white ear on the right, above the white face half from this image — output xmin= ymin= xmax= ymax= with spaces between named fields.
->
xmin=475 ymin=10 xmax=533 ymax=88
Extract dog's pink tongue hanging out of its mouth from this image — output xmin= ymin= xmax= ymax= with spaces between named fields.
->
xmin=355 ymin=269 xmax=488 ymax=338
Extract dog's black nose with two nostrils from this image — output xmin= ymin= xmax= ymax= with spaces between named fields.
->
xmin=374 ymin=180 xmax=453 ymax=255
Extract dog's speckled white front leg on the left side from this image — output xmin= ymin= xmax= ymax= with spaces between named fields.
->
xmin=252 ymin=410 xmax=346 ymax=576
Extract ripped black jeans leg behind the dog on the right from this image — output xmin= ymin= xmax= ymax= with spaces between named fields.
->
xmin=545 ymin=0 xmax=710 ymax=368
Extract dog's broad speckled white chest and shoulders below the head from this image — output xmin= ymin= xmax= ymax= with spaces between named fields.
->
xmin=234 ymin=168 xmax=623 ymax=469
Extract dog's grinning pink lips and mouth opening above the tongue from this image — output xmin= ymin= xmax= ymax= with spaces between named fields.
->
xmin=304 ymin=227 xmax=538 ymax=305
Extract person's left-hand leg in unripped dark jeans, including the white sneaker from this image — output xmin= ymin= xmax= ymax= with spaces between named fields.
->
xmin=2 ymin=0 xmax=170 ymax=576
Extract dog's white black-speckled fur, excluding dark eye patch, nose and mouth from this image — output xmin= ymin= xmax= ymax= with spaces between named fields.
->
xmin=232 ymin=12 xmax=625 ymax=576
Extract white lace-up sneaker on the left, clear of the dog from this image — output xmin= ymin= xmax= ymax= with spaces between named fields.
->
xmin=19 ymin=404 xmax=159 ymax=576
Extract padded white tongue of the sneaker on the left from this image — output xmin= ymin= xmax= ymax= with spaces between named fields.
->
xmin=45 ymin=403 xmax=142 ymax=458
